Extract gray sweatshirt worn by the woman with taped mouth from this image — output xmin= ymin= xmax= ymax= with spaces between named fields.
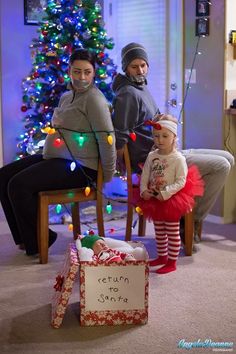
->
xmin=43 ymin=85 xmax=116 ymax=182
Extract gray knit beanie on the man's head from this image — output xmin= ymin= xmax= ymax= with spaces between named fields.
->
xmin=121 ymin=43 xmax=149 ymax=71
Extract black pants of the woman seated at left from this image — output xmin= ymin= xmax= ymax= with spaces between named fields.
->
xmin=0 ymin=155 xmax=97 ymax=255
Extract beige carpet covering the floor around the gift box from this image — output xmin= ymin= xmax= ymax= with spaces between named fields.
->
xmin=0 ymin=210 xmax=236 ymax=354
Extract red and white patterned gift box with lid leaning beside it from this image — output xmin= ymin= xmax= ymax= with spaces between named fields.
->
xmin=52 ymin=242 xmax=149 ymax=328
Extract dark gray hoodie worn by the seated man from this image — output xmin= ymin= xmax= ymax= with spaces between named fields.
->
xmin=112 ymin=74 xmax=159 ymax=172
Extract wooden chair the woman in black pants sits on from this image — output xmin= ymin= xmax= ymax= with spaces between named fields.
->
xmin=37 ymin=161 xmax=105 ymax=264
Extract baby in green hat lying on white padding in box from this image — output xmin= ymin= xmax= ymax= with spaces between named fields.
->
xmin=76 ymin=235 xmax=146 ymax=264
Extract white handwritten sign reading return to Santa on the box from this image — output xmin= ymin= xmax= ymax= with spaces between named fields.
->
xmin=85 ymin=264 xmax=145 ymax=311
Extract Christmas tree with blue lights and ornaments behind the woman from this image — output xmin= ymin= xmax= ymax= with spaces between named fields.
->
xmin=17 ymin=0 xmax=116 ymax=158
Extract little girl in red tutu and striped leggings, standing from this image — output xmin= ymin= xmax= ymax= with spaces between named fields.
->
xmin=137 ymin=115 xmax=203 ymax=274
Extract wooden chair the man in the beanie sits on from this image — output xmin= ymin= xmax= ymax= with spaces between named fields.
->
xmin=124 ymin=145 xmax=197 ymax=256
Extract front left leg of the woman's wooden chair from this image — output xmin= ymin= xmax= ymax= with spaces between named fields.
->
xmin=38 ymin=196 xmax=48 ymax=264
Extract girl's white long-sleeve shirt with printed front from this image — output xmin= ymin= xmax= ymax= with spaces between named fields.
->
xmin=140 ymin=149 xmax=188 ymax=200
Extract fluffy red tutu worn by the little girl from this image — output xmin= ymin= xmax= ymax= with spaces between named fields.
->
xmin=134 ymin=165 xmax=204 ymax=221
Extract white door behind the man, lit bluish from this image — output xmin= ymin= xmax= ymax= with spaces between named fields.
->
xmin=104 ymin=0 xmax=183 ymax=147
